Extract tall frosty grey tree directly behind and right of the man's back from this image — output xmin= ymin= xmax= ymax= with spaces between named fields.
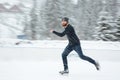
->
xmin=74 ymin=0 xmax=101 ymax=40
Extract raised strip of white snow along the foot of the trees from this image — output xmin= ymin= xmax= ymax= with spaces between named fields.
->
xmin=0 ymin=38 xmax=120 ymax=50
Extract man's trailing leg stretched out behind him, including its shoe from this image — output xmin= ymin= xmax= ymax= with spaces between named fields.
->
xmin=74 ymin=45 xmax=99 ymax=70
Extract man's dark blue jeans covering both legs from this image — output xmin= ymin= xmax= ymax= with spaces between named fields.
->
xmin=62 ymin=45 xmax=96 ymax=70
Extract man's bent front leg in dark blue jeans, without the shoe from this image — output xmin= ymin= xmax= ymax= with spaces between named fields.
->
xmin=62 ymin=46 xmax=72 ymax=71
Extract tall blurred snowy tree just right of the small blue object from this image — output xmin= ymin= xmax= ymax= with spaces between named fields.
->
xmin=24 ymin=0 xmax=46 ymax=39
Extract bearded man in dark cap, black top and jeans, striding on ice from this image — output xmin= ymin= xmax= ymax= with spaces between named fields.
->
xmin=51 ymin=17 xmax=99 ymax=74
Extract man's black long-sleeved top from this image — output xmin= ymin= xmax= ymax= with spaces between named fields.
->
xmin=53 ymin=24 xmax=80 ymax=46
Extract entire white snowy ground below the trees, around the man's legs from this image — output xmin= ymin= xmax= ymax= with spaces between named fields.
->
xmin=0 ymin=39 xmax=120 ymax=80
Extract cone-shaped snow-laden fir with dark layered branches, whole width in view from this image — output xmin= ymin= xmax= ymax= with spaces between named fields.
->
xmin=96 ymin=2 xmax=118 ymax=41
